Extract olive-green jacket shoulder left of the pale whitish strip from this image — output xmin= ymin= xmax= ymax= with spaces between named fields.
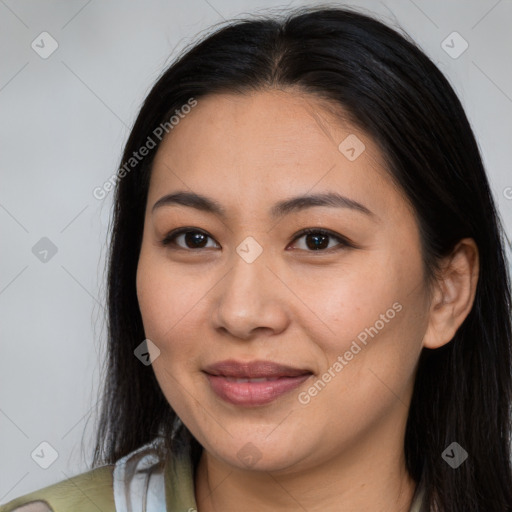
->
xmin=0 ymin=465 xmax=116 ymax=512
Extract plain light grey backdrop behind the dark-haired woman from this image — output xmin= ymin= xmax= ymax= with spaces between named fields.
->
xmin=0 ymin=0 xmax=512 ymax=503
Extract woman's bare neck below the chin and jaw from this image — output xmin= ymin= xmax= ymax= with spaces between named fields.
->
xmin=195 ymin=422 xmax=416 ymax=512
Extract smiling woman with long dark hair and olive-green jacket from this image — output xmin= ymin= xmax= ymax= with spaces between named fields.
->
xmin=0 ymin=8 xmax=512 ymax=512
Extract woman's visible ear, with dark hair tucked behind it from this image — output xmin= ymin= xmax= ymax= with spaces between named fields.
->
xmin=423 ymin=238 xmax=479 ymax=349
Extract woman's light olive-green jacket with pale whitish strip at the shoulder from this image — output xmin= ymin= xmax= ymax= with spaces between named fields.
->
xmin=0 ymin=441 xmax=423 ymax=512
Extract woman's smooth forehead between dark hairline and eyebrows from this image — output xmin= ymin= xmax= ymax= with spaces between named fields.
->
xmin=149 ymin=90 xmax=400 ymax=218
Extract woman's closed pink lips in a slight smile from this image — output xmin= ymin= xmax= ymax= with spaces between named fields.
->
xmin=204 ymin=360 xmax=312 ymax=406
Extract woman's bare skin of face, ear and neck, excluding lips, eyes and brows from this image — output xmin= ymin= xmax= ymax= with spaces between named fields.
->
xmin=137 ymin=90 xmax=478 ymax=512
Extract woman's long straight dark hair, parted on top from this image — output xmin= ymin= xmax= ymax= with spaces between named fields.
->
xmin=93 ymin=7 xmax=512 ymax=512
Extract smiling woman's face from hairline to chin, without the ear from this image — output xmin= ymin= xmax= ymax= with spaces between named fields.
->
xmin=137 ymin=90 xmax=429 ymax=471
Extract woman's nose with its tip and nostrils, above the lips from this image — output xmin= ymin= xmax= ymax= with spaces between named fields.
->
xmin=211 ymin=247 xmax=290 ymax=340
